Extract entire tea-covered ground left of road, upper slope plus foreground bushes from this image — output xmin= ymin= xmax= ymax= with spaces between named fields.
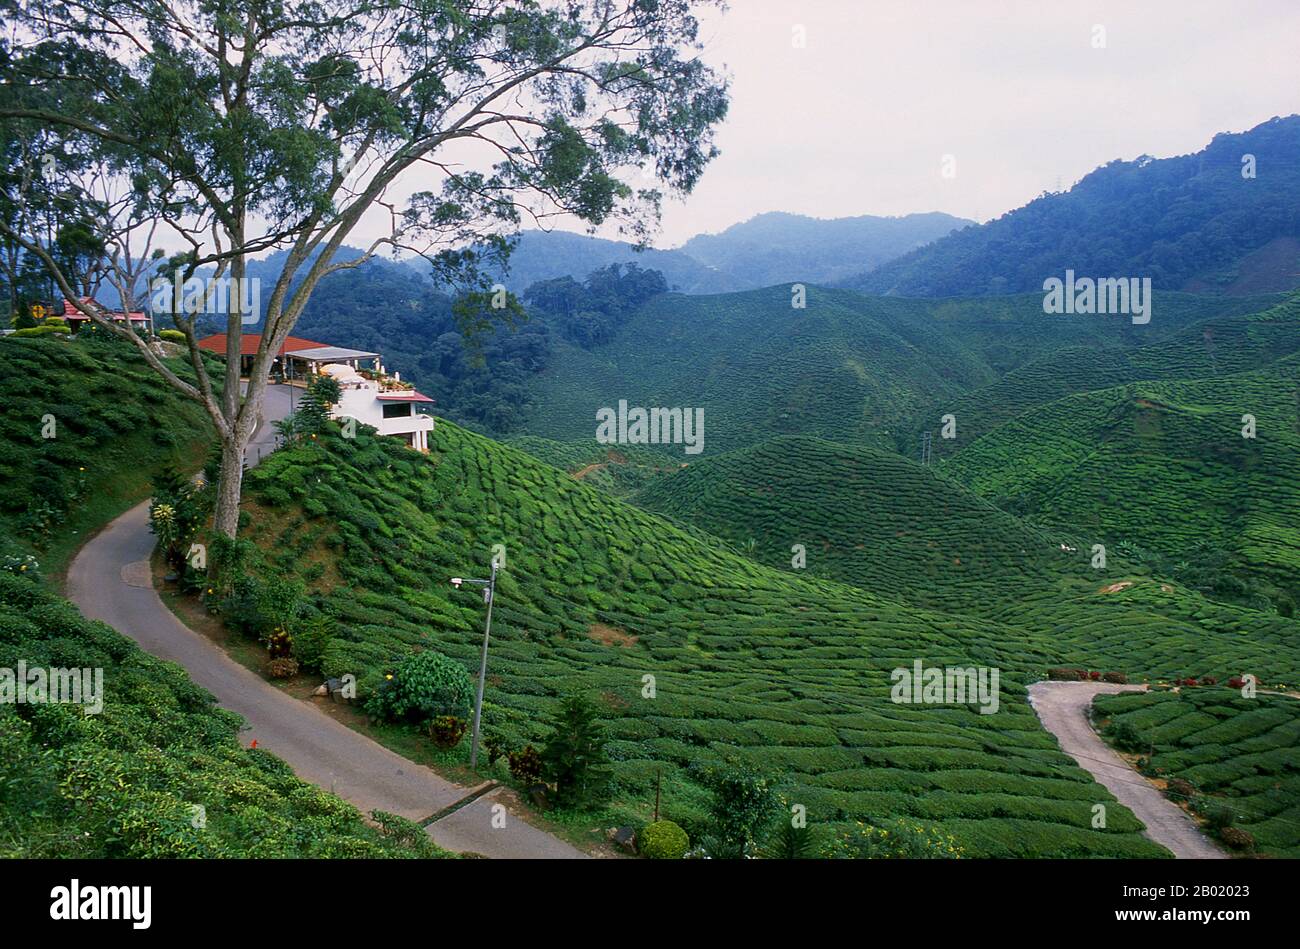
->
xmin=0 ymin=335 xmax=445 ymax=859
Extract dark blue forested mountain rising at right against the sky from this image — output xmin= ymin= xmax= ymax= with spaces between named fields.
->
xmin=846 ymin=116 xmax=1300 ymax=296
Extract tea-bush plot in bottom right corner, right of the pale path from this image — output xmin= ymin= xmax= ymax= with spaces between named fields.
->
xmin=1093 ymin=688 xmax=1300 ymax=858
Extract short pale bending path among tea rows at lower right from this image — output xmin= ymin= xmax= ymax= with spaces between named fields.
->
xmin=1030 ymin=681 xmax=1225 ymax=859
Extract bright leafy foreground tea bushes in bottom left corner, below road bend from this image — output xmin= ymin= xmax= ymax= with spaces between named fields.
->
xmin=0 ymin=571 xmax=443 ymax=859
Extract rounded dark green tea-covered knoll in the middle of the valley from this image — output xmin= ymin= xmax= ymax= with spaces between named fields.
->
xmin=633 ymin=437 xmax=1081 ymax=612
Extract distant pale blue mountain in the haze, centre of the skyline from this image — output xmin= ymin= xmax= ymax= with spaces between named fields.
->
xmin=670 ymin=212 xmax=974 ymax=289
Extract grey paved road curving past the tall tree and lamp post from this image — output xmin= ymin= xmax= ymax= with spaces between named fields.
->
xmin=68 ymin=386 xmax=586 ymax=859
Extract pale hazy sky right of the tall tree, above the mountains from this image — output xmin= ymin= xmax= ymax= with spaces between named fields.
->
xmin=644 ymin=0 xmax=1300 ymax=247
